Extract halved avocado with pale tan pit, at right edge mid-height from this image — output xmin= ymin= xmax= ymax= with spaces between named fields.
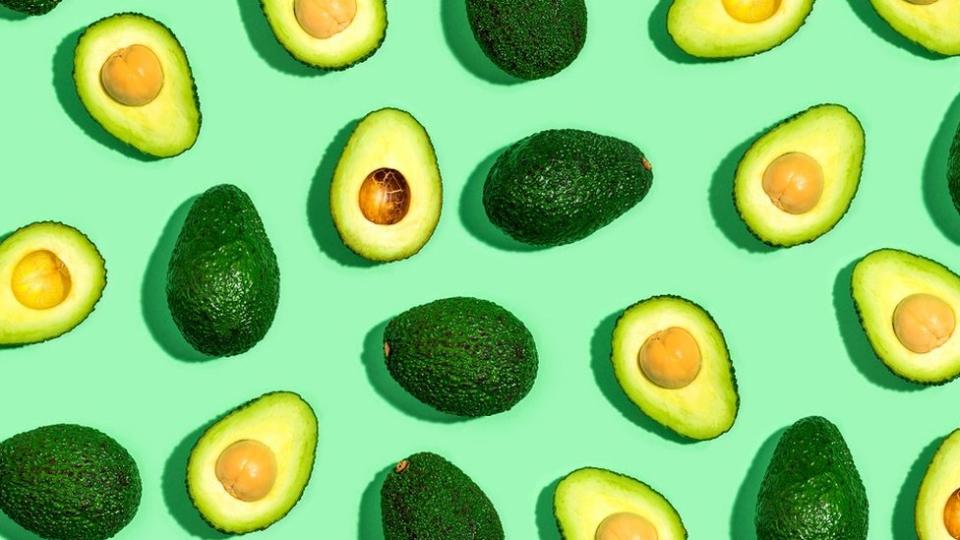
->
xmin=851 ymin=249 xmax=960 ymax=384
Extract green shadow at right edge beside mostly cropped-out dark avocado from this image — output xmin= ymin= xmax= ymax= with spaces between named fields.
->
xmin=923 ymin=97 xmax=960 ymax=244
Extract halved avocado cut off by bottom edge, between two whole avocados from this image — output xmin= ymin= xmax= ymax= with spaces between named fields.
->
xmin=553 ymin=467 xmax=687 ymax=540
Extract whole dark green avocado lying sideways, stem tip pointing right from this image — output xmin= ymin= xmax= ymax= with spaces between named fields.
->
xmin=483 ymin=129 xmax=653 ymax=247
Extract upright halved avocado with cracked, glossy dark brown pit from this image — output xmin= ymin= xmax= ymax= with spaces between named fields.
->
xmin=330 ymin=108 xmax=443 ymax=262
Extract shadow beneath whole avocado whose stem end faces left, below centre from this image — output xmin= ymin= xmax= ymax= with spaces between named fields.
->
xmin=363 ymin=320 xmax=467 ymax=424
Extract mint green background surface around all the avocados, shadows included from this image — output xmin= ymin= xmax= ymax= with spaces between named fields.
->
xmin=0 ymin=0 xmax=960 ymax=540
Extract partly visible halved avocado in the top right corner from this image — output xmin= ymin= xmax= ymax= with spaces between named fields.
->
xmin=870 ymin=0 xmax=960 ymax=56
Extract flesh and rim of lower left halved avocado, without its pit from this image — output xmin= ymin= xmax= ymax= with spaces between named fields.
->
xmin=187 ymin=392 xmax=317 ymax=534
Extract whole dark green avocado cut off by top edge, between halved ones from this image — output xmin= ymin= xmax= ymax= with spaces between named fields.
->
xmin=464 ymin=0 xmax=587 ymax=80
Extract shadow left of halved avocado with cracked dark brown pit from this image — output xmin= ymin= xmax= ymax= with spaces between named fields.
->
xmin=307 ymin=120 xmax=377 ymax=268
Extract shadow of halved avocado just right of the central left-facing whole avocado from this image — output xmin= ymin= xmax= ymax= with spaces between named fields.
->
xmin=590 ymin=311 xmax=696 ymax=444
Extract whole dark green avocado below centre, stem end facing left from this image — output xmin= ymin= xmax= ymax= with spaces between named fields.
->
xmin=383 ymin=298 xmax=538 ymax=417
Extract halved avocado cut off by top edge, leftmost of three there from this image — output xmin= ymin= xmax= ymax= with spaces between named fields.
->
xmin=260 ymin=0 xmax=387 ymax=70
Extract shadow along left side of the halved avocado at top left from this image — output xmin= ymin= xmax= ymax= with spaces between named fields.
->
xmin=53 ymin=29 xmax=158 ymax=162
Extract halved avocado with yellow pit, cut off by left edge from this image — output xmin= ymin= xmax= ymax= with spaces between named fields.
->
xmin=0 ymin=221 xmax=107 ymax=345
